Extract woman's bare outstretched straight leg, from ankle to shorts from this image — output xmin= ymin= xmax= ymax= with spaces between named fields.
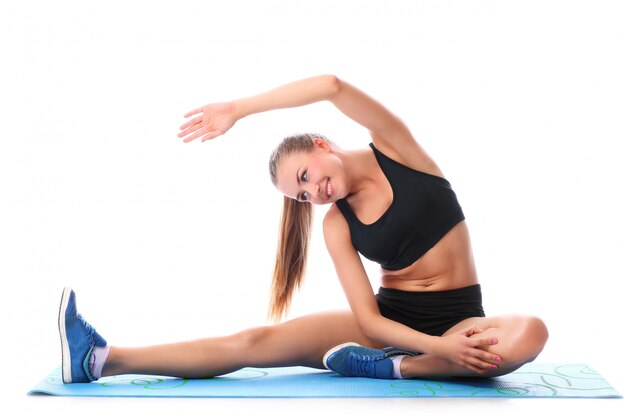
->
xmin=102 ymin=311 xmax=383 ymax=378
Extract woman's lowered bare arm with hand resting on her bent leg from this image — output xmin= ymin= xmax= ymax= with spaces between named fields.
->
xmin=324 ymin=206 xmax=497 ymax=373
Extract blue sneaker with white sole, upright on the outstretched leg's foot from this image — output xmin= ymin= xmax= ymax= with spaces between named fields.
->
xmin=59 ymin=288 xmax=106 ymax=384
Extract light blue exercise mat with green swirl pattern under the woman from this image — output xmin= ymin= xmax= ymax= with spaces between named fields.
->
xmin=28 ymin=363 xmax=622 ymax=398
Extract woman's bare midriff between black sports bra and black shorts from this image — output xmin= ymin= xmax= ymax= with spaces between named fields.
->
xmin=380 ymin=220 xmax=478 ymax=291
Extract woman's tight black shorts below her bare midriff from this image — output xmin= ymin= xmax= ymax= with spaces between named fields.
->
xmin=376 ymin=284 xmax=485 ymax=336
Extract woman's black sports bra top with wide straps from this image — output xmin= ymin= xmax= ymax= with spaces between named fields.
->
xmin=337 ymin=143 xmax=465 ymax=270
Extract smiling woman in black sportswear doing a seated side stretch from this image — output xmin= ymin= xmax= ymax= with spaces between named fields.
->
xmin=59 ymin=75 xmax=548 ymax=382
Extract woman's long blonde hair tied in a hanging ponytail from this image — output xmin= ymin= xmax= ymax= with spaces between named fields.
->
xmin=268 ymin=133 xmax=332 ymax=322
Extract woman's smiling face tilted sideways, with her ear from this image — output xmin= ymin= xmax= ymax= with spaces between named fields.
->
xmin=276 ymin=140 xmax=349 ymax=204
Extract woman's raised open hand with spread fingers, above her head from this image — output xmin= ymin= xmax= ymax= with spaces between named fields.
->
xmin=178 ymin=102 xmax=238 ymax=143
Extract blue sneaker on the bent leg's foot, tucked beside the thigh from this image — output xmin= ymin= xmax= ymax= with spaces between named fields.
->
xmin=323 ymin=342 xmax=417 ymax=379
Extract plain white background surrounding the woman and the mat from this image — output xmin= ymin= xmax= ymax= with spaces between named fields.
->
xmin=0 ymin=0 xmax=626 ymax=415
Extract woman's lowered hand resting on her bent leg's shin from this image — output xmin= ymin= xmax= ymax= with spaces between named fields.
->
xmin=433 ymin=327 xmax=502 ymax=374
